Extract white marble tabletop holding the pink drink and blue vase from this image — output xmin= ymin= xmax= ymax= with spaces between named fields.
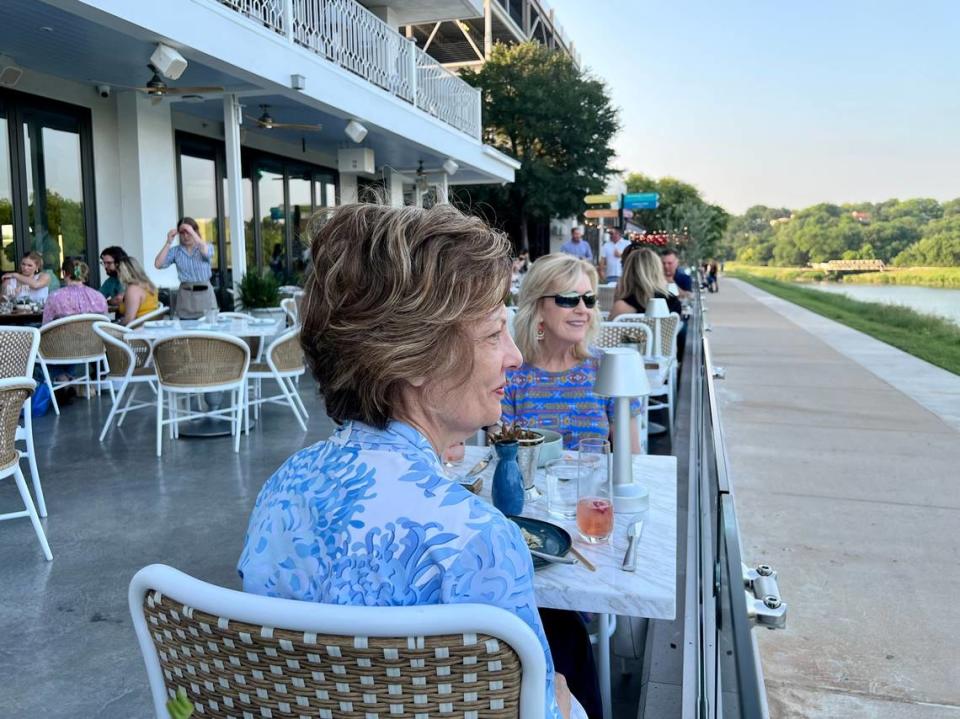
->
xmin=451 ymin=447 xmax=677 ymax=619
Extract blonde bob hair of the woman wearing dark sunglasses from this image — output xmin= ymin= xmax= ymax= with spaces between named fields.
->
xmin=513 ymin=253 xmax=600 ymax=364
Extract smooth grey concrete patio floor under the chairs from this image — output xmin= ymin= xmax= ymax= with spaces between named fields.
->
xmin=0 ymin=377 xmax=666 ymax=719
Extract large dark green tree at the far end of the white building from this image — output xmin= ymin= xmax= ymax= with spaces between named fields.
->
xmin=461 ymin=42 xmax=620 ymax=247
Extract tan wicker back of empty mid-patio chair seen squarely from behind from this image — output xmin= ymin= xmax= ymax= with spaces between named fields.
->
xmin=153 ymin=335 xmax=247 ymax=387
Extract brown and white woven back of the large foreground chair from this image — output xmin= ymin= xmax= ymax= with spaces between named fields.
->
xmin=143 ymin=590 xmax=521 ymax=719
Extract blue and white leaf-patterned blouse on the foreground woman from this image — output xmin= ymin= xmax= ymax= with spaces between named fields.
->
xmin=237 ymin=421 xmax=560 ymax=717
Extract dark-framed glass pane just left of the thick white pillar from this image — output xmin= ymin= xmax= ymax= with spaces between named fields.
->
xmin=23 ymin=122 xmax=87 ymax=285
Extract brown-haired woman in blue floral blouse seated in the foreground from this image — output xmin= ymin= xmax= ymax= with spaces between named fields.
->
xmin=238 ymin=205 xmax=584 ymax=717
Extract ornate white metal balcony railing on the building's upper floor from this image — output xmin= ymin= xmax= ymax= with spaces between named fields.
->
xmin=212 ymin=0 xmax=481 ymax=139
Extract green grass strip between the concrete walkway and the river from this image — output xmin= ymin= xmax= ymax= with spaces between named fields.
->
xmin=726 ymin=274 xmax=960 ymax=374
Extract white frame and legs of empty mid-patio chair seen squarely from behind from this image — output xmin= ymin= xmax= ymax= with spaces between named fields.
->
xmin=153 ymin=332 xmax=250 ymax=457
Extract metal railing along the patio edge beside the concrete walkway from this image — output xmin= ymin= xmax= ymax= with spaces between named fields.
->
xmin=682 ymin=286 xmax=787 ymax=719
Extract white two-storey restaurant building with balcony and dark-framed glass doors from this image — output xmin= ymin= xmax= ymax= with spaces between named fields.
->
xmin=0 ymin=0 xmax=518 ymax=296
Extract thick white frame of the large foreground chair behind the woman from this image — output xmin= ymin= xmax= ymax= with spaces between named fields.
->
xmin=127 ymin=564 xmax=547 ymax=719
